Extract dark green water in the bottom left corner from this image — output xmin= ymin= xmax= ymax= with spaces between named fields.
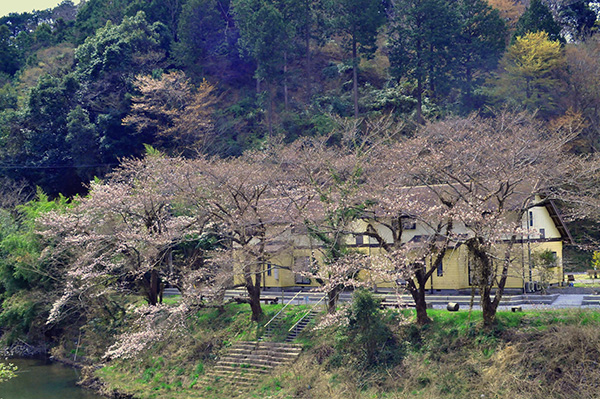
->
xmin=0 ymin=359 xmax=106 ymax=399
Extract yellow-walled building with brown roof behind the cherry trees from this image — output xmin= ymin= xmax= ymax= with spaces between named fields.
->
xmin=236 ymin=197 xmax=572 ymax=291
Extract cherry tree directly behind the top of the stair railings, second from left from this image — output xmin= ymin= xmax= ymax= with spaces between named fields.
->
xmin=188 ymin=150 xmax=289 ymax=321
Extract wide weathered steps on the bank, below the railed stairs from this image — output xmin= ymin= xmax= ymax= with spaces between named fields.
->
xmin=205 ymin=341 xmax=302 ymax=389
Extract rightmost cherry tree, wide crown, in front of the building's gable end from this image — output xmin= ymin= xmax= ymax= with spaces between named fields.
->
xmin=392 ymin=113 xmax=598 ymax=326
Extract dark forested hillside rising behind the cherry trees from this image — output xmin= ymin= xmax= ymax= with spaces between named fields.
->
xmin=0 ymin=0 xmax=600 ymax=196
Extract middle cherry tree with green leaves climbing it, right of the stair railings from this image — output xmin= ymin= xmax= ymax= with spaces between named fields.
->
xmin=278 ymin=117 xmax=401 ymax=313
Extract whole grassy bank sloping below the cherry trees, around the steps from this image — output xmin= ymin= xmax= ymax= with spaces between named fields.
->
xmin=91 ymin=304 xmax=600 ymax=399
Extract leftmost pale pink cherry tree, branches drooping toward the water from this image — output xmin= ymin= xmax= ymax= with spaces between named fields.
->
xmin=41 ymin=153 xmax=207 ymax=321
